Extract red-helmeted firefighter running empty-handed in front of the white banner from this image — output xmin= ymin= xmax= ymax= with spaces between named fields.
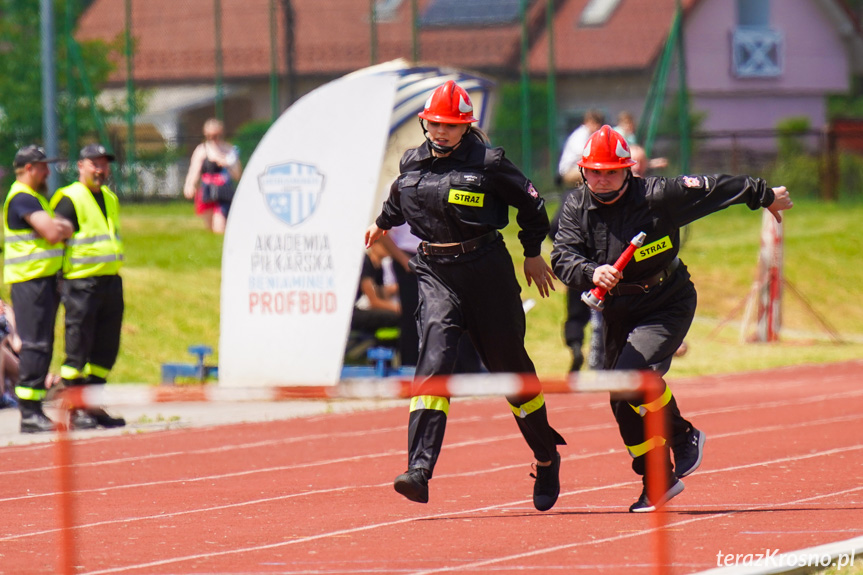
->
xmin=365 ymin=81 xmax=564 ymax=511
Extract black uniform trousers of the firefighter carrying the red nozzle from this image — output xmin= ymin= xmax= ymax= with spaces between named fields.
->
xmin=603 ymin=264 xmax=697 ymax=475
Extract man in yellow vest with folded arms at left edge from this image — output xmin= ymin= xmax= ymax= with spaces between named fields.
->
xmin=3 ymin=146 xmax=73 ymax=433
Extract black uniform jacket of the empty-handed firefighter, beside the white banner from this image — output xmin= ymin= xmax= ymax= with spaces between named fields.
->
xmin=375 ymin=132 xmax=548 ymax=257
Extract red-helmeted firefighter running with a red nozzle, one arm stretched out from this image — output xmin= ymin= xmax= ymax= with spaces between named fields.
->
xmin=551 ymin=126 xmax=792 ymax=513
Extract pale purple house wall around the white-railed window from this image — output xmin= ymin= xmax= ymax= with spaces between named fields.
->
xmin=684 ymin=0 xmax=850 ymax=142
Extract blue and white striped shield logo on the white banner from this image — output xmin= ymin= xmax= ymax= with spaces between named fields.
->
xmin=258 ymin=162 xmax=324 ymax=226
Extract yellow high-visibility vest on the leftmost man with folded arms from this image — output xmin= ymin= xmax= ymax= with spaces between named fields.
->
xmin=3 ymin=181 xmax=63 ymax=284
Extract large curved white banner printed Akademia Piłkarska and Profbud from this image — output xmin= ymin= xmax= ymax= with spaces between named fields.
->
xmin=219 ymin=62 xmax=488 ymax=387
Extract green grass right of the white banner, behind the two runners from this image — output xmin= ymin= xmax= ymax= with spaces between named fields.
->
xmin=506 ymin=198 xmax=863 ymax=377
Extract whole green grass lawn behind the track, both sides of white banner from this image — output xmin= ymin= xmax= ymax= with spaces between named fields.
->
xmin=4 ymin=198 xmax=863 ymax=383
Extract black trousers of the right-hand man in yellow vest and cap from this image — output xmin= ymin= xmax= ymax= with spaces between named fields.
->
xmin=61 ymin=275 xmax=124 ymax=385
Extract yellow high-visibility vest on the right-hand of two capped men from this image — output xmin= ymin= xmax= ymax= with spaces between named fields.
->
xmin=51 ymin=182 xmax=123 ymax=279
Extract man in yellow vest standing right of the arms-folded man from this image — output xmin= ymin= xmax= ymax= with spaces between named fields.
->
xmin=51 ymin=144 xmax=126 ymax=429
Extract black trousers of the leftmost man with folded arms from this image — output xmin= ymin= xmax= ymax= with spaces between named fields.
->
xmin=11 ymin=276 xmax=60 ymax=412
